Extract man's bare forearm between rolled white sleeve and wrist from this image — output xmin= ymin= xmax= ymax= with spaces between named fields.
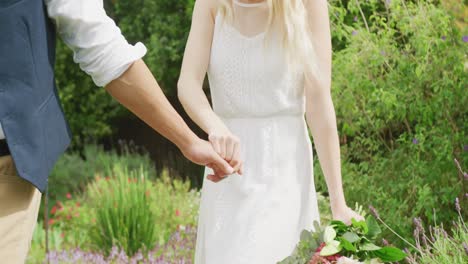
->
xmin=106 ymin=60 xmax=198 ymax=149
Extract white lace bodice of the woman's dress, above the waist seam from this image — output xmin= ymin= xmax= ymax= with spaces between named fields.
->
xmin=208 ymin=9 xmax=305 ymax=118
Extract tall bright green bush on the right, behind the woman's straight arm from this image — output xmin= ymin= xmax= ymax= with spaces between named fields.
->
xmin=316 ymin=0 xmax=468 ymax=244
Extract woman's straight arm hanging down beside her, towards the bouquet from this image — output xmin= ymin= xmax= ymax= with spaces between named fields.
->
xmin=305 ymin=0 xmax=362 ymax=222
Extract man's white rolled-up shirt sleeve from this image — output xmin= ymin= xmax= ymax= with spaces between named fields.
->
xmin=45 ymin=0 xmax=146 ymax=86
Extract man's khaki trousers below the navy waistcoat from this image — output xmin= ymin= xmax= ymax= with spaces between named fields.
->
xmin=0 ymin=156 xmax=41 ymax=264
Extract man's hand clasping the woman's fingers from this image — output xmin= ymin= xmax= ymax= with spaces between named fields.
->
xmin=181 ymin=139 xmax=234 ymax=182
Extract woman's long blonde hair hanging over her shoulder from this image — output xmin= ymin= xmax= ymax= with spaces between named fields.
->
xmin=219 ymin=0 xmax=318 ymax=79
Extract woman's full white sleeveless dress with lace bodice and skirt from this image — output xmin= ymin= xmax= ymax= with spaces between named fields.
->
xmin=195 ymin=3 xmax=319 ymax=264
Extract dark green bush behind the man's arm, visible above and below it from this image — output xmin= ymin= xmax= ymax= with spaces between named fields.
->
xmin=55 ymin=0 xmax=195 ymax=144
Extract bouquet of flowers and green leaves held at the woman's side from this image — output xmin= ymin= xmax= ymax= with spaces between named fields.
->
xmin=279 ymin=216 xmax=406 ymax=264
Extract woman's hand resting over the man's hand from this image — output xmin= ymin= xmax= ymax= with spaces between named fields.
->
xmin=208 ymin=130 xmax=242 ymax=174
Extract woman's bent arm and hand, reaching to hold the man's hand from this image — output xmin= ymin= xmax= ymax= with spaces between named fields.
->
xmin=178 ymin=0 xmax=242 ymax=178
